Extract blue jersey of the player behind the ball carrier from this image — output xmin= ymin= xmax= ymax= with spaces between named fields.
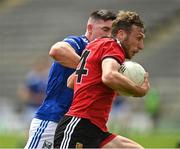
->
xmin=35 ymin=35 xmax=89 ymax=122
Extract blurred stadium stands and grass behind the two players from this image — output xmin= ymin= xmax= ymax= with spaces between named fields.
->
xmin=0 ymin=0 xmax=180 ymax=148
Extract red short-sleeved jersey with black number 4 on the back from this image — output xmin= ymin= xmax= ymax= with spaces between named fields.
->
xmin=66 ymin=38 xmax=125 ymax=132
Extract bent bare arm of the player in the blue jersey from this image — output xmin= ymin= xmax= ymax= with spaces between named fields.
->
xmin=49 ymin=41 xmax=80 ymax=69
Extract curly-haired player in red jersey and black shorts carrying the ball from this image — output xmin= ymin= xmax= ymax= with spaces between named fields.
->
xmin=54 ymin=11 xmax=150 ymax=148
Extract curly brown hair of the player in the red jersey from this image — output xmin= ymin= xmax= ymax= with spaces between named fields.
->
xmin=112 ymin=11 xmax=145 ymax=37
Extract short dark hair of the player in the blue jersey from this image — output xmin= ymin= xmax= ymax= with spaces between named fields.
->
xmin=90 ymin=9 xmax=116 ymax=21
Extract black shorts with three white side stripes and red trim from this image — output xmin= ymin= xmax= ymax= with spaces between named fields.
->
xmin=54 ymin=116 xmax=115 ymax=148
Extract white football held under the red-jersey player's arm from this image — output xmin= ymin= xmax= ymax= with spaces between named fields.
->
xmin=119 ymin=61 xmax=146 ymax=96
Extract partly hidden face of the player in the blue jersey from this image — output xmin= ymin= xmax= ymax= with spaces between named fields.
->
xmin=92 ymin=20 xmax=112 ymax=40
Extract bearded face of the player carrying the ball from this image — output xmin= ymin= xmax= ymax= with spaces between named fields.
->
xmin=121 ymin=25 xmax=145 ymax=59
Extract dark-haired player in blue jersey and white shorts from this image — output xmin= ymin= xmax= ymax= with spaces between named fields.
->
xmin=25 ymin=9 xmax=116 ymax=149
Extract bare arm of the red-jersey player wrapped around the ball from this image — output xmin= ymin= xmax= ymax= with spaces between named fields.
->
xmin=102 ymin=58 xmax=149 ymax=97
